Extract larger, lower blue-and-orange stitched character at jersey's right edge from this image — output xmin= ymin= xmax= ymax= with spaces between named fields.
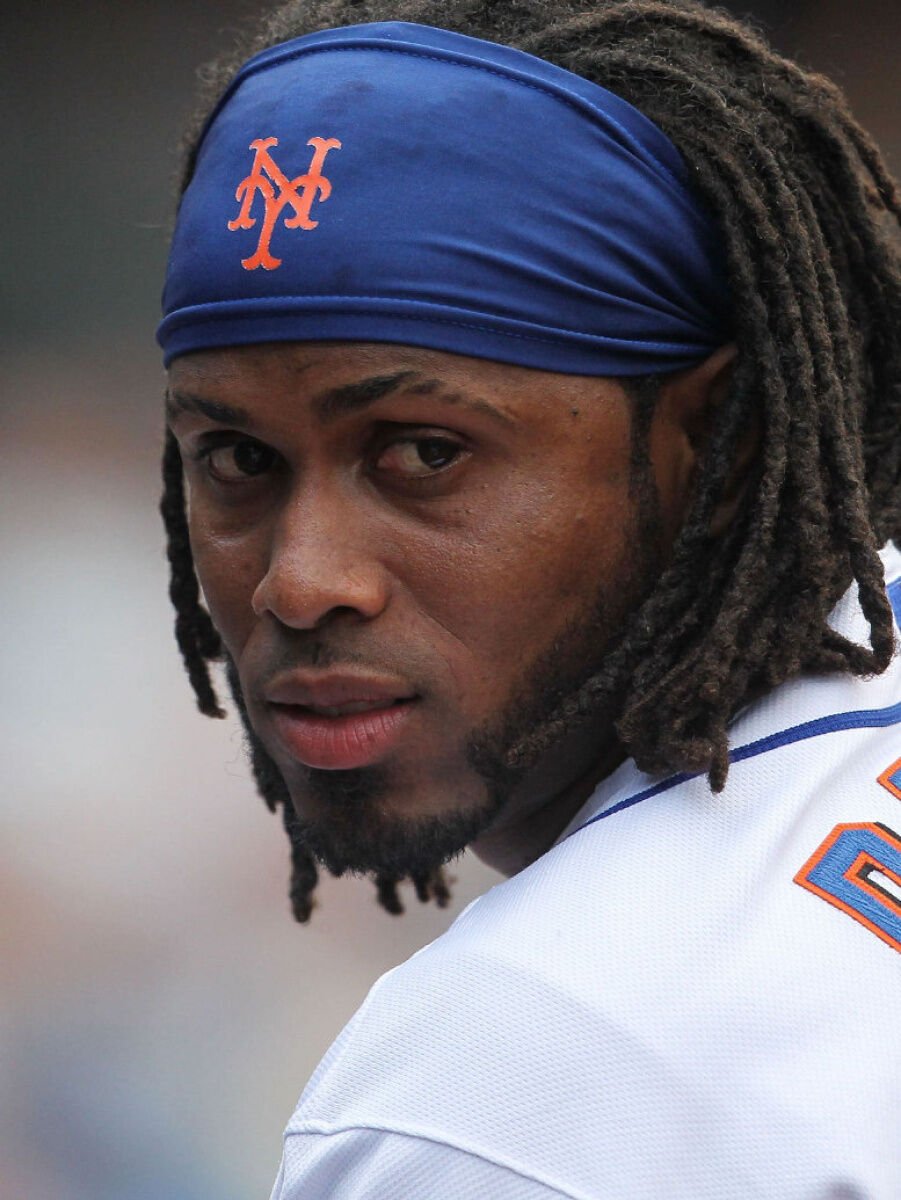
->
xmin=794 ymin=823 xmax=901 ymax=950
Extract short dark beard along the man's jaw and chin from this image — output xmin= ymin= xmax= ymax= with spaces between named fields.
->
xmin=226 ymin=472 xmax=665 ymax=881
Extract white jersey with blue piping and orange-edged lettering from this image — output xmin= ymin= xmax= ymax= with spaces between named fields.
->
xmin=272 ymin=547 xmax=901 ymax=1200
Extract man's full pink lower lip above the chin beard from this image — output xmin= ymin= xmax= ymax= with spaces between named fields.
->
xmin=269 ymin=696 xmax=418 ymax=770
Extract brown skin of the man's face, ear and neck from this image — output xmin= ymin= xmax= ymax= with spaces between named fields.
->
xmin=167 ymin=343 xmax=739 ymax=875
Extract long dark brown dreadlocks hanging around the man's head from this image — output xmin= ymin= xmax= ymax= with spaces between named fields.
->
xmin=162 ymin=0 xmax=901 ymax=920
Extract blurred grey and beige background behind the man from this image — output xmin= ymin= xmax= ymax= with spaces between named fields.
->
xmin=0 ymin=0 xmax=901 ymax=1200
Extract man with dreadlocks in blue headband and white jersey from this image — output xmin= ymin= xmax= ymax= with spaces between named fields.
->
xmin=160 ymin=0 xmax=901 ymax=1200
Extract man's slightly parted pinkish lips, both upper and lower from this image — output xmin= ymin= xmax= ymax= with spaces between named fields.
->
xmin=264 ymin=672 xmax=418 ymax=770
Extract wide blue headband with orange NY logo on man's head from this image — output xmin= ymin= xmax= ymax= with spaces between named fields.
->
xmin=157 ymin=22 xmax=729 ymax=376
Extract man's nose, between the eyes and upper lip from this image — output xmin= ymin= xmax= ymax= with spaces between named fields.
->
xmin=251 ymin=482 xmax=390 ymax=629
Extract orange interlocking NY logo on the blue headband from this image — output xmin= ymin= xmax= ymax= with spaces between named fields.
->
xmin=228 ymin=138 xmax=341 ymax=271
